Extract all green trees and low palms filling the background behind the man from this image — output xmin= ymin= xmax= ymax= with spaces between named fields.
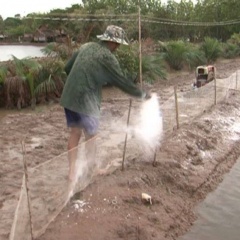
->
xmin=0 ymin=0 xmax=240 ymax=109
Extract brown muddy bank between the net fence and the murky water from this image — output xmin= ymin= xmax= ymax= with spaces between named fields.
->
xmin=39 ymin=90 xmax=240 ymax=240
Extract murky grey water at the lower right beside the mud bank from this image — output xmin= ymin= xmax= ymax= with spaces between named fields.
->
xmin=179 ymin=158 xmax=240 ymax=240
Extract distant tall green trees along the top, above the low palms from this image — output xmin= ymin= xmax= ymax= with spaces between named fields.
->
xmin=0 ymin=0 xmax=240 ymax=42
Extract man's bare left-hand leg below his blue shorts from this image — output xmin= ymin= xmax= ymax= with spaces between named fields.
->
xmin=68 ymin=127 xmax=82 ymax=181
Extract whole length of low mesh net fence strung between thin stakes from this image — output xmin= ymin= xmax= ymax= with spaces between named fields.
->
xmin=0 ymin=72 xmax=239 ymax=240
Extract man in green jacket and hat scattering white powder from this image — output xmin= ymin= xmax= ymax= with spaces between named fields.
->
xmin=60 ymin=25 xmax=149 ymax=181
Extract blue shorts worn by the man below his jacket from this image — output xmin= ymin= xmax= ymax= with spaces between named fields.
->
xmin=64 ymin=108 xmax=99 ymax=135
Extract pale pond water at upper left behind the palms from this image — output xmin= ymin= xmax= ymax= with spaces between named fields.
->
xmin=0 ymin=45 xmax=44 ymax=61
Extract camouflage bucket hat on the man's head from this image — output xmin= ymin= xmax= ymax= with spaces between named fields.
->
xmin=97 ymin=25 xmax=128 ymax=45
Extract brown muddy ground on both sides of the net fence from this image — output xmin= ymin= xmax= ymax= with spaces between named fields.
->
xmin=0 ymin=59 xmax=240 ymax=240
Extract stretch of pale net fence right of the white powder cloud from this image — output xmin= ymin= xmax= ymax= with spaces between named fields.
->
xmin=161 ymin=72 xmax=239 ymax=133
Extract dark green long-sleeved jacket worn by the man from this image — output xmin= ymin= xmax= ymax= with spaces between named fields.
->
xmin=60 ymin=42 xmax=144 ymax=118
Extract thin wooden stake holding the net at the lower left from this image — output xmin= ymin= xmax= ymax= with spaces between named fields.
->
xmin=22 ymin=142 xmax=34 ymax=240
